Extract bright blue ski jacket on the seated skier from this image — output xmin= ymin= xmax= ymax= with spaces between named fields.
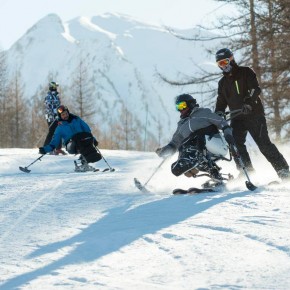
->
xmin=43 ymin=114 xmax=91 ymax=153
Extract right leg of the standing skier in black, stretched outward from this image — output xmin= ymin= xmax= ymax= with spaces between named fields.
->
xmin=248 ymin=116 xmax=289 ymax=177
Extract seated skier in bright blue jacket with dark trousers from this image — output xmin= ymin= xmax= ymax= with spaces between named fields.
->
xmin=39 ymin=105 xmax=102 ymax=172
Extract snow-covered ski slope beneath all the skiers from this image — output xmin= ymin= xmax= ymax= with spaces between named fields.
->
xmin=0 ymin=148 xmax=290 ymax=290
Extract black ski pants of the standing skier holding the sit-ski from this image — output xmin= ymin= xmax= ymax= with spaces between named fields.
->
xmin=231 ymin=115 xmax=289 ymax=172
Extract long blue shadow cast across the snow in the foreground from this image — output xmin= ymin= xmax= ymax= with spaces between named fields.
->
xmin=0 ymin=191 xmax=255 ymax=289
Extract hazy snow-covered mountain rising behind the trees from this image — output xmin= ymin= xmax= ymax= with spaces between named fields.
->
xmin=7 ymin=14 xmax=218 ymax=144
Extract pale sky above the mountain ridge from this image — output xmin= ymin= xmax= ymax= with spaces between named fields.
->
xmin=0 ymin=0 xmax=231 ymax=49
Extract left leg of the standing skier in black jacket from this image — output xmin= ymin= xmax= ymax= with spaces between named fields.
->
xmin=231 ymin=120 xmax=254 ymax=171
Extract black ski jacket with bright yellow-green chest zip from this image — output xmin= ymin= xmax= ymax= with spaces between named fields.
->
xmin=215 ymin=63 xmax=264 ymax=119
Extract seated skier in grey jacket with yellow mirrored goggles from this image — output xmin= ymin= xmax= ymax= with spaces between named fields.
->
xmin=156 ymin=94 xmax=234 ymax=185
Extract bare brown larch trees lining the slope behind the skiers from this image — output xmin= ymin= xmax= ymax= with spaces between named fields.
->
xmin=0 ymin=0 xmax=290 ymax=151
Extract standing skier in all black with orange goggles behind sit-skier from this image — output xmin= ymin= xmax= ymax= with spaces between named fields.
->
xmin=215 ymin=48 xmax=290 ymax=179
